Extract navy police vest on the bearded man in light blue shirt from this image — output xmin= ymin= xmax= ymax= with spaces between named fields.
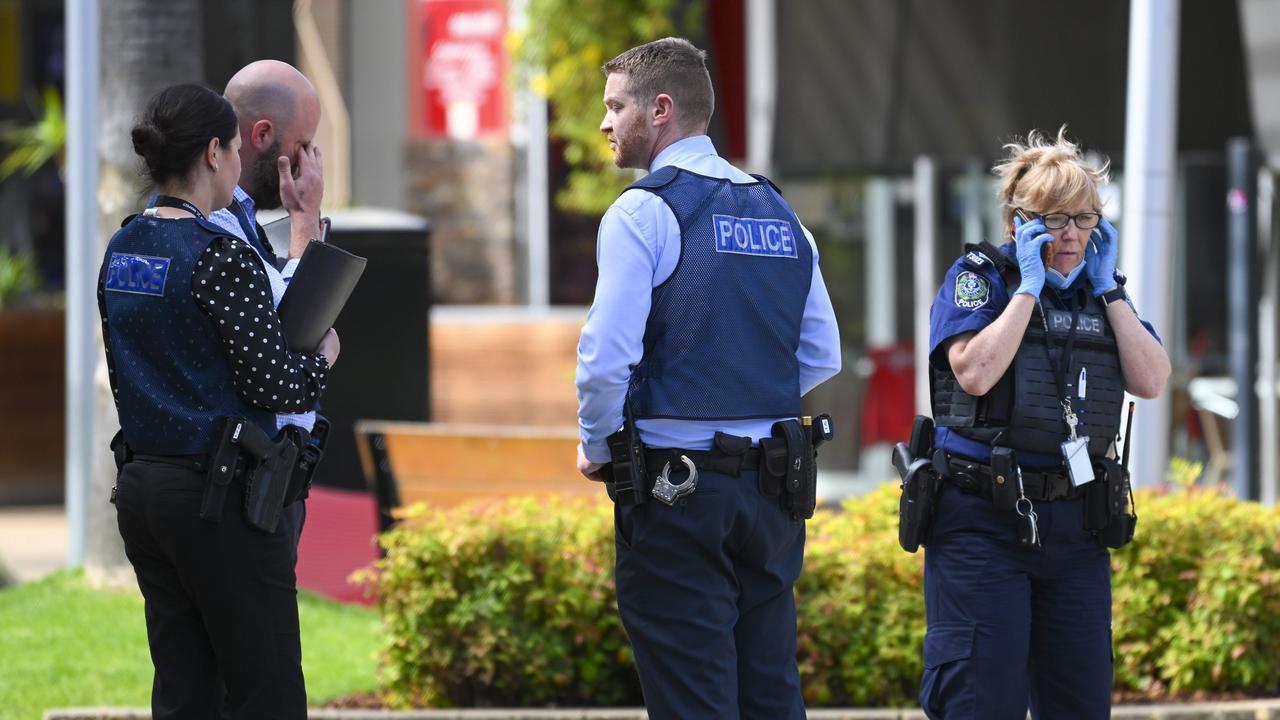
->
xmin=627 ymin=167 xmax=813 ymax=420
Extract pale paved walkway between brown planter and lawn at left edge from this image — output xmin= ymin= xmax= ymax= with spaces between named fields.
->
xmin=0 ymin=505 xmax=68 ymax=583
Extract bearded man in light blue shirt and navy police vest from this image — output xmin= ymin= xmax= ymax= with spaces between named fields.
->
xmin=577 ymin=38 xmax=840 ymax=720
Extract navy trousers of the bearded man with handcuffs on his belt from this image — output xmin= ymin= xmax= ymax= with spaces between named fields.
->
xmin=616 ymin=470 xmax=805 ymax=720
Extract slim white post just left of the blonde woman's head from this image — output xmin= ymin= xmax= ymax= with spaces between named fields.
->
xmin=913 ymin=155 xmax=938 ymax=415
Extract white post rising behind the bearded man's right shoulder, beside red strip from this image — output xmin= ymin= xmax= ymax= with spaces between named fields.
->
xmin=746 ymin=0 xmax=778 ymax=176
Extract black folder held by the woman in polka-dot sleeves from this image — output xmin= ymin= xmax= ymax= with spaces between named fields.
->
xmin=276 ymin=240 xmax=366 ymax=352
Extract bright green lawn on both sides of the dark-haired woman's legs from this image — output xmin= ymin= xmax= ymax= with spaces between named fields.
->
xmin=0 ymin=571 xmax=381 ymax=720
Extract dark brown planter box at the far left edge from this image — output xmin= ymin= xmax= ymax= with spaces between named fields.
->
xmin=0 ymin=309 xmax=67 ymax=505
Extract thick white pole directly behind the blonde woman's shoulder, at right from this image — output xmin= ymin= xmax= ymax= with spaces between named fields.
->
xmin=1120 ymin=0 xmax=1179 ymax=486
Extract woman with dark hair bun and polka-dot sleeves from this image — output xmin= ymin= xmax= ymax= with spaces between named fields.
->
xmin=97 ymin=85 xmax=338 ymax=720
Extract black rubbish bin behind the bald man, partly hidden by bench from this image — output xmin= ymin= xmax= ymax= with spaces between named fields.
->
xmin=315 ymin=208 xmax=431 ymax=491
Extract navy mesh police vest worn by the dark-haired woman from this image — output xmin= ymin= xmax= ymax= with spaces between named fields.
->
xmin=99 ymin=210 xmax=275 ymax=455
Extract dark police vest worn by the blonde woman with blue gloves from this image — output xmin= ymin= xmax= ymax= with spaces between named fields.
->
xmin=931 ymin=243 xmax=1124 ymax=457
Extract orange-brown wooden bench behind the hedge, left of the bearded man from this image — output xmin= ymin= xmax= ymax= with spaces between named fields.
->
xmin=355 ymin=420 xmax=604 ymax=529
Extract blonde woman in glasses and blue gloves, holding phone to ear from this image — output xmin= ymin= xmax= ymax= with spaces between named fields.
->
xmin=920 ymin=127 xmax=1170 ymax=720
